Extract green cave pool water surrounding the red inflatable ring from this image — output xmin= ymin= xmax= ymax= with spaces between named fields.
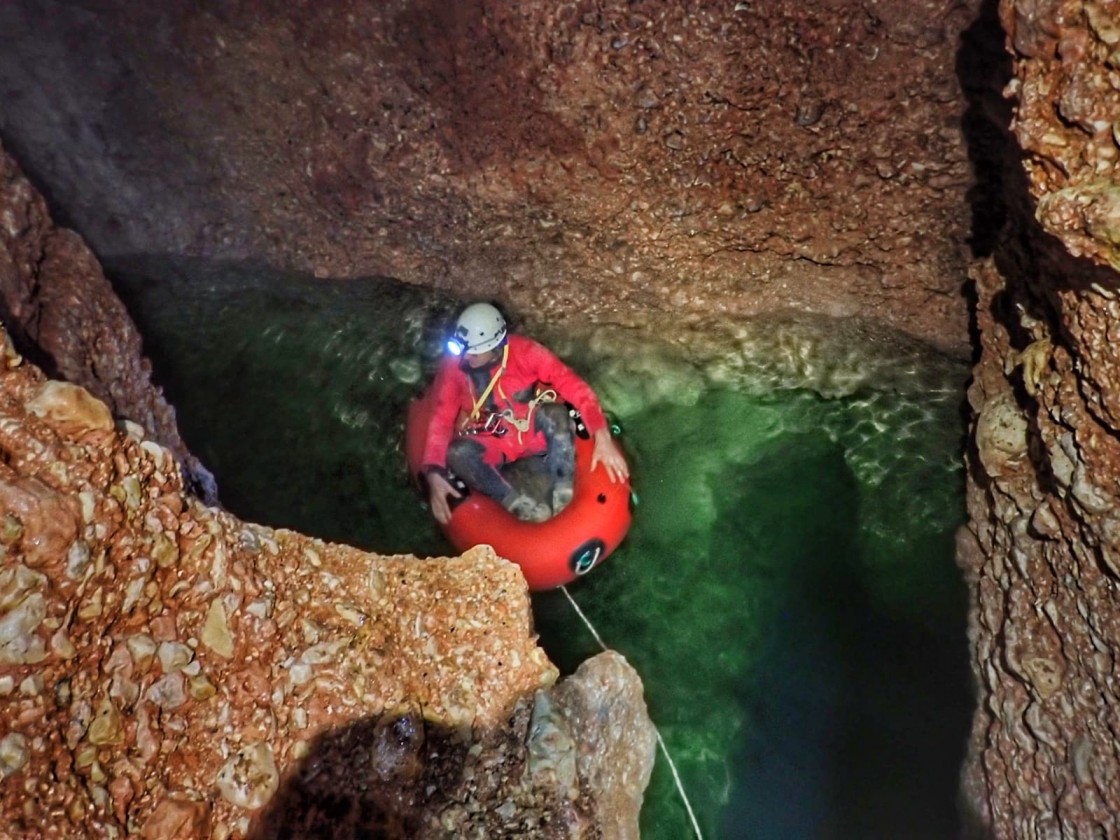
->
xmin=110 ymin=259 xmax=971 ymax=840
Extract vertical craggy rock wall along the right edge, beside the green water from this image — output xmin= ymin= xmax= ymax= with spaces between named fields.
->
xmin=959 ymin=0 xmax=1120 ymax=839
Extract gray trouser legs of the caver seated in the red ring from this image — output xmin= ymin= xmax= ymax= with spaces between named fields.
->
xmin=447 ymin=402 xmax=576 ymax=502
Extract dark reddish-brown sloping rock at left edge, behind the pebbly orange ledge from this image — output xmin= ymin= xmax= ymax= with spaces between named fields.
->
xmin=0 ymin=146 xmax=216 ymax=501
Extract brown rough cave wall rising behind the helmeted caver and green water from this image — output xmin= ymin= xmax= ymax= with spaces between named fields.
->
xmin=0 ymin=0 xmax=979 ymax=351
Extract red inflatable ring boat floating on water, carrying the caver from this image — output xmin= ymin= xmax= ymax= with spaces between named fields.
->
xmin=404 ymin=392 xmax=631 ymax=590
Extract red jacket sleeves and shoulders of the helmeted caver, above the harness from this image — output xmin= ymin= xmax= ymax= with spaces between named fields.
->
xmin=421 ymin=335 xmax=607 ymax=467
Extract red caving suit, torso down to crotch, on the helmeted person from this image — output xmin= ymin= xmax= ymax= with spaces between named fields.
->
xmin=421 ymin=335 xmax=607 ymax=469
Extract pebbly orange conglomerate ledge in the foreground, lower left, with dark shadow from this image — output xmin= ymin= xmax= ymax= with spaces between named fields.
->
xmin=0 ymin=333 xmax=654 ymax=840
